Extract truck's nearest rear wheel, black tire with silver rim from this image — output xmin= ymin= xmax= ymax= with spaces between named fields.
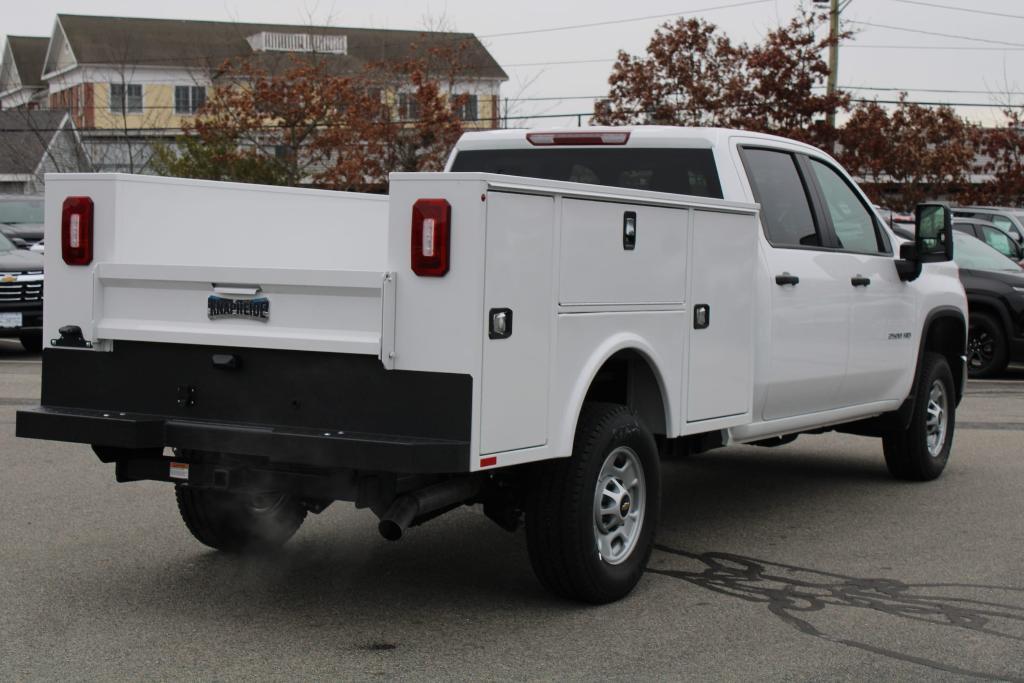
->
xmin=526 ymin=403 xmax=662 ymax=604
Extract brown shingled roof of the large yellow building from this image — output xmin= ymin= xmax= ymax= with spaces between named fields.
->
xmin=54 ymin=14 xmax=508 ymax=81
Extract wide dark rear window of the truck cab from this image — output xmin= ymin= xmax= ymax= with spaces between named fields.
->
xmin=452 ymin=147 xmax=722 ymax=199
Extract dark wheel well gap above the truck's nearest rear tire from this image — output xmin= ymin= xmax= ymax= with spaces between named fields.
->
xmin=584 ymin=349 xmax=668 ymax=434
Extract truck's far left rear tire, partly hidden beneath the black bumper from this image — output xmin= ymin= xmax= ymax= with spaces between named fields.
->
xmin=174 ymin=485 xmax=306 ymax=553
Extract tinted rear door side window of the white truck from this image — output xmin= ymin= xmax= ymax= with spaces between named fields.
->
xmin=742 ymin=147 xmax=822 ymax=247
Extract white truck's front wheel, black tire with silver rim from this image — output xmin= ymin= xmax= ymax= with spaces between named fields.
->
xmin=882 ymin=353 xmax=956 ymax=481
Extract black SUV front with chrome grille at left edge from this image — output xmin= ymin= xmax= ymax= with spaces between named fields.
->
xmin=0 ymin=233 xmax=43 ymax=351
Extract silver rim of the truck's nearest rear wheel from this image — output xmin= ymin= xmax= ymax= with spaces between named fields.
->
xmin=594 ymin=445 xmax=647 ymax=564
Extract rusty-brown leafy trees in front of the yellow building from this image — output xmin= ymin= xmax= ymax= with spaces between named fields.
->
xmin=157 ymin=44 xmax=475 ymax=191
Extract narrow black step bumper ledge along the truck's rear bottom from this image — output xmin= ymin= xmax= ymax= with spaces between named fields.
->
xmin=16 ymin=407 xmax=469 ymax=473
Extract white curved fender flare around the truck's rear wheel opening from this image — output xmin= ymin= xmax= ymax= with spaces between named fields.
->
xmin=555 ymin=333 xmax=676 ymax=457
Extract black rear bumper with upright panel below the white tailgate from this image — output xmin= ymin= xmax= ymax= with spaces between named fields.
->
xmin=16 ymin=342 xmax=472 ymax=473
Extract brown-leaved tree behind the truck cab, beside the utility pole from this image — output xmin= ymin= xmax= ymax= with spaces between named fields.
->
xmin=594 ymin=12 xmax=849 ymax=150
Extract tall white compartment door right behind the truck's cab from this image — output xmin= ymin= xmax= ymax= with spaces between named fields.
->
xmin=686 ymin=210 xmax=758 ymax=422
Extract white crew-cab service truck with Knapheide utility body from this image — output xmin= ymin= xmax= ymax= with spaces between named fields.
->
xmin=17 ymin=127 xmax=967 ymax=602
